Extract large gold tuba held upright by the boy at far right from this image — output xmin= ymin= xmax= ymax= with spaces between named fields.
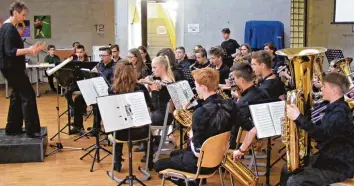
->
xmin=276 ymin=47 xmax=327 ymax=171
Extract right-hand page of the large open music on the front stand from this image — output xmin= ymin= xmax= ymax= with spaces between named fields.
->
xmin=125 ymin=92 xmax=152 ymax=127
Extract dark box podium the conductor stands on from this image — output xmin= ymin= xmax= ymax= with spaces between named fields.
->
xmin=0 ymin=127 xmax=48 ymax=164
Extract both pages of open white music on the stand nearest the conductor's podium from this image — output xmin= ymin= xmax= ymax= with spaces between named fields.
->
xmin=77 ymin=77 xmax=108 ymax=106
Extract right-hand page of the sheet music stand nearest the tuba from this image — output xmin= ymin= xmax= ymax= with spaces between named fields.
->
xmin=268 ymin=101 xmax=286 ymax=135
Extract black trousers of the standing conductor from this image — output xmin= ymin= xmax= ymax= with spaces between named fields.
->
xmin=1 ymin=69 xmax=41 ymax=134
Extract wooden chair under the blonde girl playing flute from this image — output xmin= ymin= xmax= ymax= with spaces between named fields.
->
xmin=151 ymin=100 xmax=175 ymax=163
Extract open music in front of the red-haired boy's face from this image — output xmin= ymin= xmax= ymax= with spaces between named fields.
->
xmin=167 ymin=80 xmax=197 ymax=110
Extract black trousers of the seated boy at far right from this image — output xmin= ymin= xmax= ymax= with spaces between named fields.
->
xmin=280 ymin=156 xmax=347 ymax=186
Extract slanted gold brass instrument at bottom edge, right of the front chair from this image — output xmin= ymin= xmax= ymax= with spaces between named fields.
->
xmin=222 ymin=152 xmax=261 ymax=186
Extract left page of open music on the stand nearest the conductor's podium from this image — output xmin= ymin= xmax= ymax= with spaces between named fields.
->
xmin=77 ymin=79 xmax=98 ymax=106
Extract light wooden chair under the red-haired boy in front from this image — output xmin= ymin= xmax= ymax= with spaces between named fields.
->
xmin=159 ymin=131 xmax=230 ymax=186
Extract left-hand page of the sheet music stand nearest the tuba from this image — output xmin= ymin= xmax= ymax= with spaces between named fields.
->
xmin=249 ymin=103 xmax=276 ymax=139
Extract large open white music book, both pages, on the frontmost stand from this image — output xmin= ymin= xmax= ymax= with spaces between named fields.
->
xmin=97 ymin=92 xmax=152 ymax=132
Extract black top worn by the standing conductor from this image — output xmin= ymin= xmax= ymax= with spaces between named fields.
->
xmin=0 ymin=23 xmax=26 ymax=71
